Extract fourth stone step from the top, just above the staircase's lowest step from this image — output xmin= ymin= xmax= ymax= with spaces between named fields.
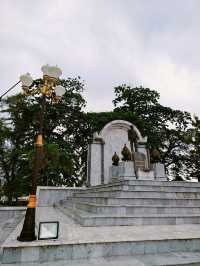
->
xmin=68 ymin=201 xmax=200 ymax=215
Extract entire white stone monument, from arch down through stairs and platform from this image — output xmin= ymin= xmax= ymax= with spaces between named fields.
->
xmin=0 ymin=120 xmax=200 ymax=266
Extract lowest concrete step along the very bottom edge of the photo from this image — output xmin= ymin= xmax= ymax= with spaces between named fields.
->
xmin=0 ymin=252 xmax=200 ymax=266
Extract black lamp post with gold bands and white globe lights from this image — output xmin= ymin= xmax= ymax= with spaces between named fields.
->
xmin=17 ymin=65 xmax=65 ymax=242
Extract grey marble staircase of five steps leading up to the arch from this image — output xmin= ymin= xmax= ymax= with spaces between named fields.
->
xmin=60 ymin=180 xmax=200 ymax=226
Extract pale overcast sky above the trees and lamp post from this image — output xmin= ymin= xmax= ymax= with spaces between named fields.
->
xmin=0 ymin=0 xmax=200 ymax=115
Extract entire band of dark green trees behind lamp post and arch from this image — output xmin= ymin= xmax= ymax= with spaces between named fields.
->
xmin=0 ymin=80 xmax=200 ymax=203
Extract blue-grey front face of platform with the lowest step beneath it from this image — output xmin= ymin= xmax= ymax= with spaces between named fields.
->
xmin=2 ymin=231 xmax=200 ymax=266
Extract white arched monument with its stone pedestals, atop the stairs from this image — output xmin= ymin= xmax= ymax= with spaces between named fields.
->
xmin=87 ymin=120 xmax=166 ymax=186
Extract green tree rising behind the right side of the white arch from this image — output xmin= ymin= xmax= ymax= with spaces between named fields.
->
xmin=113 ymin=84 xmax=192 ymax=179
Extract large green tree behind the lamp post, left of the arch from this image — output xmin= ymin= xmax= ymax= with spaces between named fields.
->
xmin=0 ymin=75 xmax=87 ymax=200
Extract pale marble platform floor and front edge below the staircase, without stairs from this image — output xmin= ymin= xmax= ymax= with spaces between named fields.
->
xmin=2 ymin=207 xmax=200 ymax=266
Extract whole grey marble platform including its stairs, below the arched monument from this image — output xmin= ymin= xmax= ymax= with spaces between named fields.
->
xmin=2 ymin=180 xmax=200 ymax=266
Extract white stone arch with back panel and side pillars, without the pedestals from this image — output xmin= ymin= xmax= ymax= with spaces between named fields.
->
xmin=88 ymin=120 xmax=165 ymax=185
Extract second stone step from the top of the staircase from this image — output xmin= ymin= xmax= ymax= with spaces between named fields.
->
xmin=74 ymin=190 xmax=200 ymax=199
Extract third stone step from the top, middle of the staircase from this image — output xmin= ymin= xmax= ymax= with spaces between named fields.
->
xmin=61 ymin=195 xmax=200 ymax=207
